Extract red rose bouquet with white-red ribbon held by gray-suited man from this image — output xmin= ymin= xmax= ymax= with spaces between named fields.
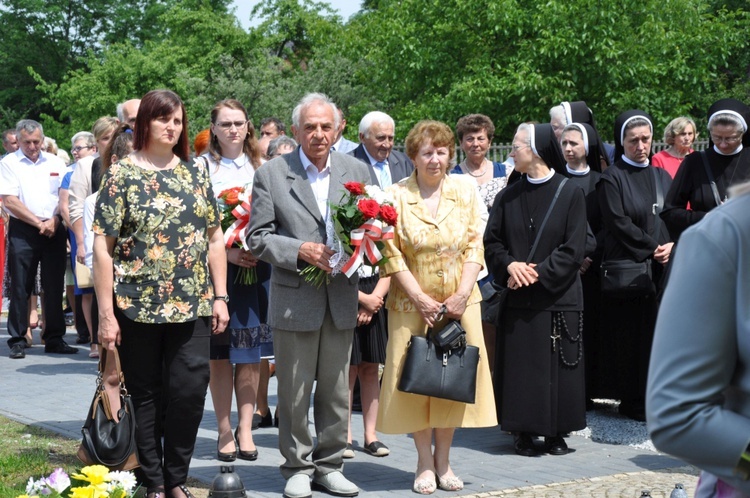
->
xmin=302 ymin=182 xmax=398 ymax=287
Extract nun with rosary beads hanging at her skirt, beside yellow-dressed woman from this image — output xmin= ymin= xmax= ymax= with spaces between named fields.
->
xmin=484 ymin=124 xmax=586 ymax=456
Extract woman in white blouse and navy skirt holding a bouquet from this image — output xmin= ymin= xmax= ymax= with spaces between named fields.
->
xmin=199 ymin=99 xmax=273 ymax=462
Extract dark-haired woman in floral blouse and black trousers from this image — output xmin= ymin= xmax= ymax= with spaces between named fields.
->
xmin=94 ymin=90 xmax=229 ymax=498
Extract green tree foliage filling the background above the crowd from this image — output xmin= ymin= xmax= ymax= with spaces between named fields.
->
xmin=0 ymin=0 xmax=750 ymax=148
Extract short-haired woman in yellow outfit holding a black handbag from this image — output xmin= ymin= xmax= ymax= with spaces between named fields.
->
xmin=377 ymin=121 xmax=497 ymax=494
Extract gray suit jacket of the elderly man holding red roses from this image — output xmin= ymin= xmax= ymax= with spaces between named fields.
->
xmin=248 ymin=147 xmax=370 ymax=331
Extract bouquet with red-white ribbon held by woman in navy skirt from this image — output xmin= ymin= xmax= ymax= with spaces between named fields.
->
xmin=218 ymin=185 xmax=258 ymax=285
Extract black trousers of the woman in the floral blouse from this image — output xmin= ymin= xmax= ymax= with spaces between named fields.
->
xmin=115 ymin=310 xmax=211 ymax=490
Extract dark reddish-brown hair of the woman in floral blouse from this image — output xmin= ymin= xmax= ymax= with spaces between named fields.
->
xmin=133 ymin=90 xmax=190 ymax=161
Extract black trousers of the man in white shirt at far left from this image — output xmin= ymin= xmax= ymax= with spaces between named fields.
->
xmin=8 ymin=218 xmax=67 ymax=347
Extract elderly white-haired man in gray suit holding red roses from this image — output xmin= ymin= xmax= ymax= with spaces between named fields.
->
xmin=248 ymin=93 xmax=370 ymax=498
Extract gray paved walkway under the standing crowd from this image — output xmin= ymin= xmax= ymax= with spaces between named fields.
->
xmin=0 ymin=317 xmax=696 ymax=498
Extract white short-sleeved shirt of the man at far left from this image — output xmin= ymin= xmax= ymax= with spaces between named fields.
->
xmin=0 ymin=149 xmax=67 ymax=221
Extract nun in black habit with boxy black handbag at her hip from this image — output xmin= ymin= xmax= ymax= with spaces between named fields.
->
xmin=597 ymin=110 xmax=673 ymax=420
